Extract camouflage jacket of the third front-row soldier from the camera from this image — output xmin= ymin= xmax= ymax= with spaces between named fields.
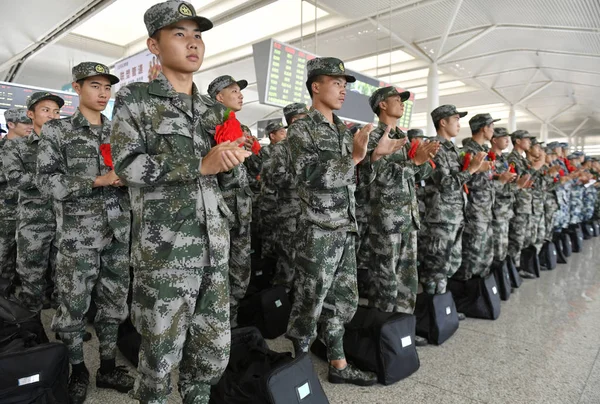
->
xmin=361 ymin=122 xmax=433 ymax=234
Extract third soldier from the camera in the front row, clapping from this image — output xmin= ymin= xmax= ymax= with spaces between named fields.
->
xmin=359 ymin=87 xmax=439 ymax=314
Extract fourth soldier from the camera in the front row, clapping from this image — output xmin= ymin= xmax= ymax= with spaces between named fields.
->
xmin=419 ymin=105 xmax=486 ymax=294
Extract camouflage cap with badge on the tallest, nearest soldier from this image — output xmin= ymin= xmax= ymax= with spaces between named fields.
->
xmin=144 ymin=0 xmax=213 ymax=37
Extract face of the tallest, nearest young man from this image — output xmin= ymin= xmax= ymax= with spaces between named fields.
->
xmin=147 ymin=20 xmax=204 ymax=73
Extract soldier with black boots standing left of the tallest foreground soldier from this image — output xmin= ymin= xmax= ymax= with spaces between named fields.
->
xmin=37 ymin=62 xmax=133 ymax=404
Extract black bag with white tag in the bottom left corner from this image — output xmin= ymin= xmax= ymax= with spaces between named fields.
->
xmin=0 ymin=340 xmax=69 ymax=404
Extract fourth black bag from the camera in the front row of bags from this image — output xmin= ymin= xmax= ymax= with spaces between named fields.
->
xmin=448 ymin=275 xmax=500 ymax=320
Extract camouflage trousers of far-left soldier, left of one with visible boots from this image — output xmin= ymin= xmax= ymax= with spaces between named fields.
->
xmin=17 ymin=200 xmax=57 ymax=312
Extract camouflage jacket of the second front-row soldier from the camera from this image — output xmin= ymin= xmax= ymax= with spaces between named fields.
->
xmin=287 ymin=108 xmax=357 ymax=232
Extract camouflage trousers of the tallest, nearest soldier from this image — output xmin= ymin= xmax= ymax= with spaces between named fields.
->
xmin=130 ymin=265 xmax=231 ymax=404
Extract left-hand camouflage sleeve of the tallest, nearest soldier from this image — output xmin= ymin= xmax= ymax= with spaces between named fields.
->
xmin=110 ymin=87 xmax=202 ymax=188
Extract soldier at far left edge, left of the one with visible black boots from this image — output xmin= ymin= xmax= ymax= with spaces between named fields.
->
xmin=2 ymin=92 xmax=65 ymax=312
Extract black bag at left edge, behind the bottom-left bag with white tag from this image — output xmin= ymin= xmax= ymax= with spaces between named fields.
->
xmin=0 ymin=296 xmax=48 ymax=344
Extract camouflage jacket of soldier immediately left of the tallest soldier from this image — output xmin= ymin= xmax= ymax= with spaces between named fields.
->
xmin=37 ymin=109 xmax=131 ymax=248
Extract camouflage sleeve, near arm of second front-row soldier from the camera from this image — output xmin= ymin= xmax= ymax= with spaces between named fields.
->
xmin=287 ymin=122 xmax=355 ymax=189
